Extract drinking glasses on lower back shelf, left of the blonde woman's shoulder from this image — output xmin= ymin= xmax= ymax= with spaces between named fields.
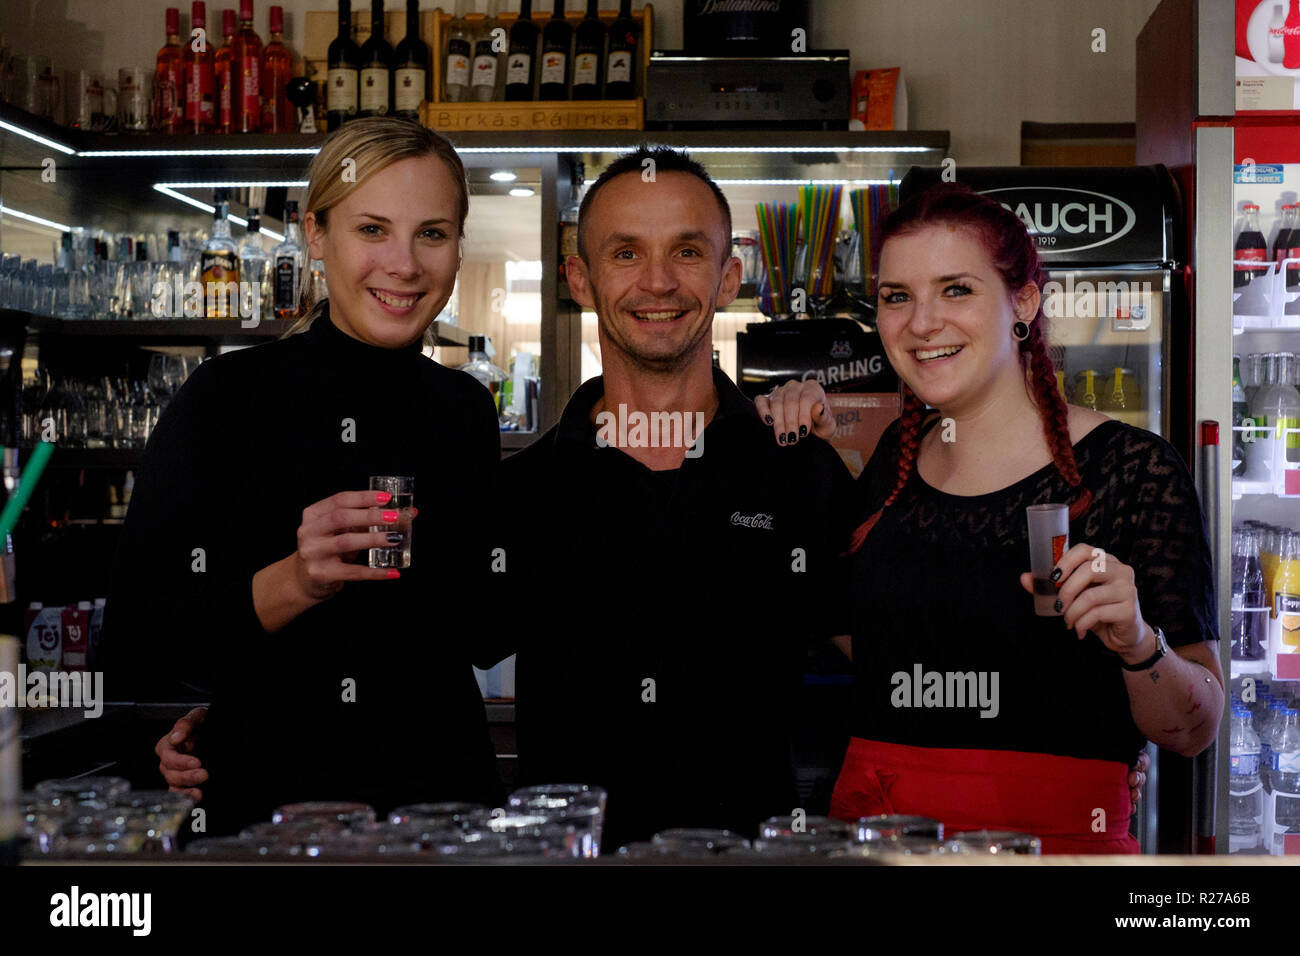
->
xmin=22 ymin=352 xmax=199 ymax=449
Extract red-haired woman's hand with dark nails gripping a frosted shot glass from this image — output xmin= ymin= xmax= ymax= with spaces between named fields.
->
xmin=1021 ymin=544 xmax=1154 ymax=663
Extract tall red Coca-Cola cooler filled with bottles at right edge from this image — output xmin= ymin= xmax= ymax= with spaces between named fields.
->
xmin=1136 ymin=0 xmax=1300 ymax=855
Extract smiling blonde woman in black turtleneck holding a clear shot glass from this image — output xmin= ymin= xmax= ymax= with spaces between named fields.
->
xmin=105 ymin=118 xmax=501 ymax=834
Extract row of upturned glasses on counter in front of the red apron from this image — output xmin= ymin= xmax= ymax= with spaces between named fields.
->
xmin=619 ymin=816 xmax=1043 ymax=862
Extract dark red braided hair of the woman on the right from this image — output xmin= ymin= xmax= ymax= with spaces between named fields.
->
xmin=849 ymin=183 xmax=1092 ymax=554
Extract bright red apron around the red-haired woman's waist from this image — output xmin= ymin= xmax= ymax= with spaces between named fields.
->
xmin=831 ymin=737 xmax=1138 ymax=853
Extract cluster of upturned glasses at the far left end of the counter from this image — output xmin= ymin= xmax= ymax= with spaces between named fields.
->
xmin=21 ymin=777 xmax=194 ymax=858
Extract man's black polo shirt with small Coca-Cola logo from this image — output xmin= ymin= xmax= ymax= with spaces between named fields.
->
xmin=503 ymin=369 xmax=859 ymax=848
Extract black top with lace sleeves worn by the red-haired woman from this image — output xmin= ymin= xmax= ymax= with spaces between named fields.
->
xmin=853 ymin=421 xmax=1218 ymax=763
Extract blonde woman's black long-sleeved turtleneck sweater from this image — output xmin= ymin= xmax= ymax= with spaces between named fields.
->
xmin=104 ymin=312 xmax=501 ymax=834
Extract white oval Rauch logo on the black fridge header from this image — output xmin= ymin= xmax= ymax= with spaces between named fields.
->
xmin=983 ymin=186 xmax=1138 ymax=255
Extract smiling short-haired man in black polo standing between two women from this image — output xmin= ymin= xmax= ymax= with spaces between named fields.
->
xmin=502 ymin=148 xmax=855 ymax=847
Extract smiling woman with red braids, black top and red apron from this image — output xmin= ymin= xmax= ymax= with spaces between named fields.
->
xmin=758 ymin=185 xmax=1223 ymax=853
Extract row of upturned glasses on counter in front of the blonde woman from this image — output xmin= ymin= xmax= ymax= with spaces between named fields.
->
xmin=186 ymin=784 xmax=606 ymax=861
